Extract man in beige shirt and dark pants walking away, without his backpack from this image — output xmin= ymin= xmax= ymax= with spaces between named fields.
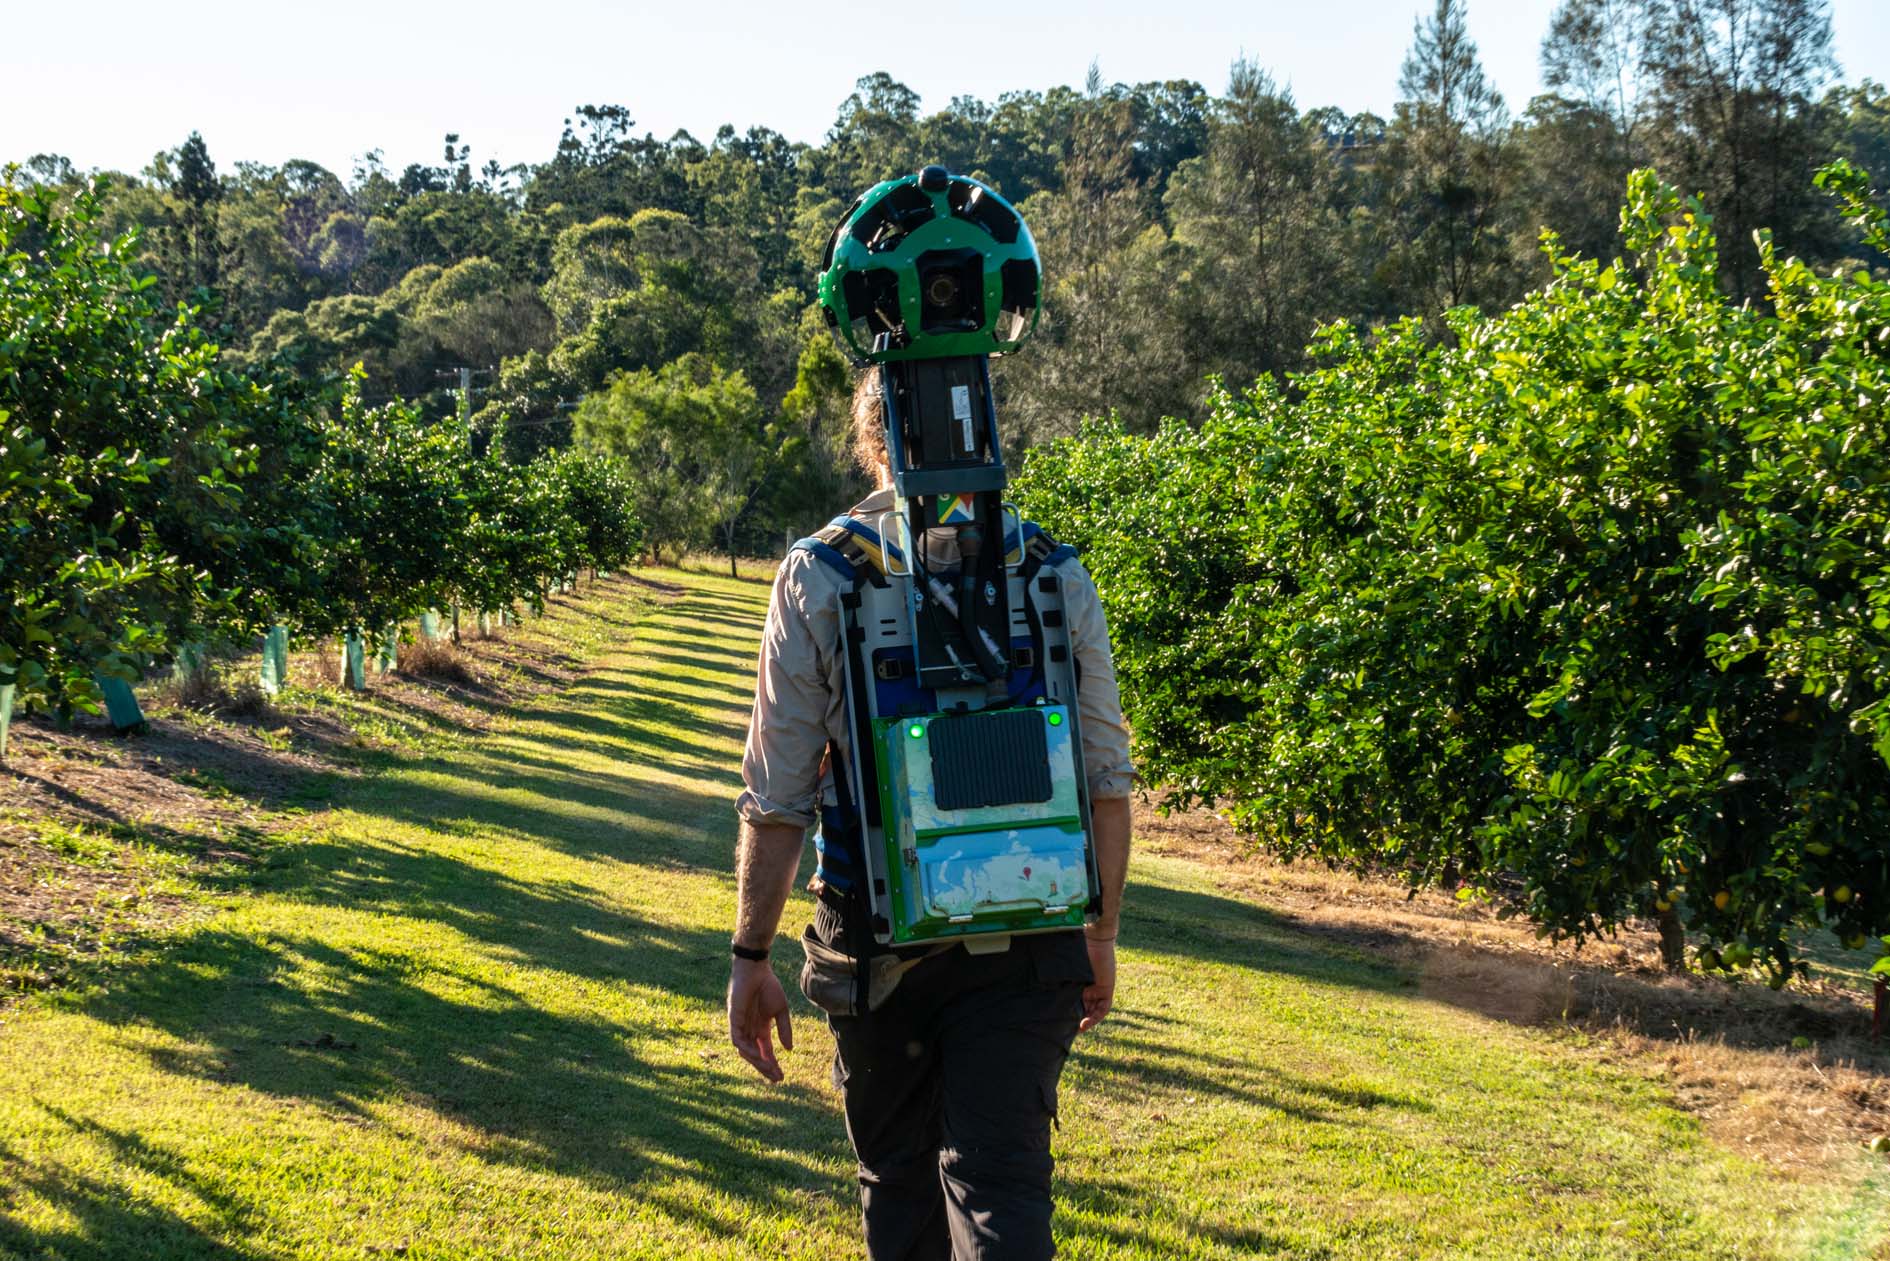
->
xmin=728 ymin=374 xmax=1132 ymax=1261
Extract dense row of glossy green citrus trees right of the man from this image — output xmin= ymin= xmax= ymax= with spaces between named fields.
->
xmin=1019 ymin=163 xmax=1890 ymax=983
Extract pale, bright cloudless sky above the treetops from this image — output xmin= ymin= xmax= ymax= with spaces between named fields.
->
xmin=11 ymin=0 xmax=1890 ymax=178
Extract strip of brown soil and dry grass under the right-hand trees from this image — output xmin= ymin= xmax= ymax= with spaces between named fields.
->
xmin=1136 ymin=802 xmax=1890 ymax=1176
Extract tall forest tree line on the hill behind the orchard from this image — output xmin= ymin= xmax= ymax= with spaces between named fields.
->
xmin=15 ymin=0 xmax=1890 ymax=550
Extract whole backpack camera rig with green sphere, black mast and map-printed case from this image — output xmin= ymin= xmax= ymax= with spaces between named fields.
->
xmin=820 ymin=166 xmax=1100 ymax=951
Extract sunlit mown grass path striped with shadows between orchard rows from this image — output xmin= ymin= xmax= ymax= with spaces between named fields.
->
xmin=0 ymin=575 xmax=1884 ymax=1261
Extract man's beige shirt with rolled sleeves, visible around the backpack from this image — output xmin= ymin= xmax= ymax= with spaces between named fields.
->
xmin=735 ymin=492 xmax=1134 ymax=828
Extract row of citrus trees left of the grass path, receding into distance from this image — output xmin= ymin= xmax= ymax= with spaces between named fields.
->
xmin=0 ymin=181 xmax=641 ymax=725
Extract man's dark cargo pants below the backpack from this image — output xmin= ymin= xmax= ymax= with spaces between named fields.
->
xmin=815 ymin=904 xmax=1092 ymax=1261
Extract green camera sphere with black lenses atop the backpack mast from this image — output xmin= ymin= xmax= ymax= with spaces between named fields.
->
xmin=820 ymin=166 xmax=1043 ymax=363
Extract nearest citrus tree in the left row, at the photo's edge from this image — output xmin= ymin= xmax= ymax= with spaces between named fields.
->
xmin=0 ymin=174 xmax=242 ymax=713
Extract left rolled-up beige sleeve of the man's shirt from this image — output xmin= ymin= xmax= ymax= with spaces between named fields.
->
xmin=735 ymin=552 xmax=837 ymax=828
